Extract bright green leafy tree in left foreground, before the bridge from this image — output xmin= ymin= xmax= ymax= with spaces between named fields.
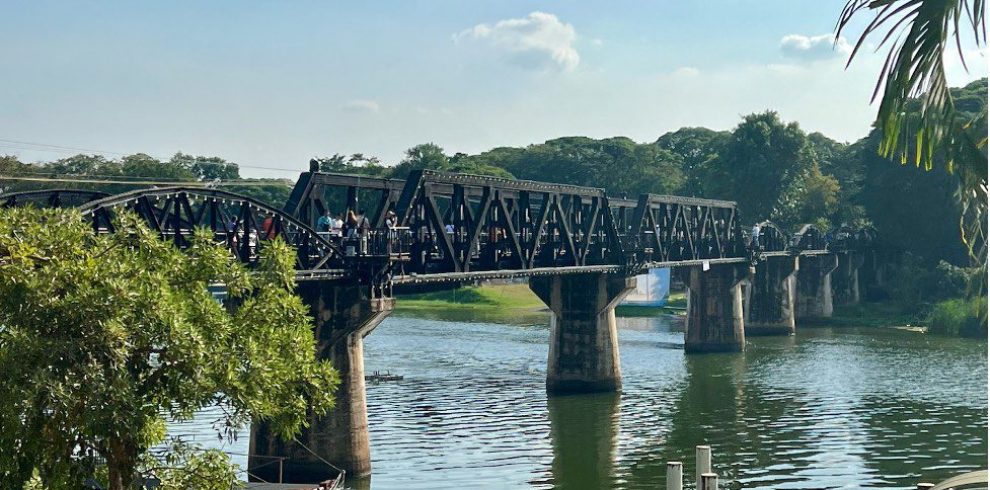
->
xmin=0 ymin=208 xmax=337 ymax=490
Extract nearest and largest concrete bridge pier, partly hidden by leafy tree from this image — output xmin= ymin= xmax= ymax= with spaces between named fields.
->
xmin=248 ymin=281 xmax=394 ymax=483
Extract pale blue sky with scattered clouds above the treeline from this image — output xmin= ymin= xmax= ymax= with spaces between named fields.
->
xmin=0 ymin=0 xmax=987 ymax=178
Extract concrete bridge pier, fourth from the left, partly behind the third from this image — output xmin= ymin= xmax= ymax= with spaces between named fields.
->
xmin=746 ymin=257 xmax=799 ymax=335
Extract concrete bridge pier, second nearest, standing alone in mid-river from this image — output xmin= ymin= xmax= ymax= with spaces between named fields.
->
xmin=529 ymin=273 xmax=636 ymax=394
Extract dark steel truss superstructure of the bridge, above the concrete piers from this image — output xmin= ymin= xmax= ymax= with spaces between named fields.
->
xmin=0 ymin=171 xmax=874 ymax=285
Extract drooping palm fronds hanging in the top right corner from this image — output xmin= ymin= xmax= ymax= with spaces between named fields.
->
xmin=836 ymin=0 xmax=988 ymax=270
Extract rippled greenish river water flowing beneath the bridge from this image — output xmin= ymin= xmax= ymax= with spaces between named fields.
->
xmin=171 ymin=314 xmax=988 ymax=490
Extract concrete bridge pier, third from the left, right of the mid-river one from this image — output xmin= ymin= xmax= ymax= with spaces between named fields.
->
xmin=680 ymin=264 xmax=751 ymax=353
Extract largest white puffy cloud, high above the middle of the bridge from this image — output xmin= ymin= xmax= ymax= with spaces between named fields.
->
xmin=454 ymin=12 xmax=581 ymax=71
